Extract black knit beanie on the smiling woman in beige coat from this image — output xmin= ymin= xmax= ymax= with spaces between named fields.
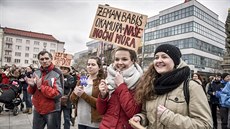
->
xmin=154 ymin=44 xmax=181 ymax=65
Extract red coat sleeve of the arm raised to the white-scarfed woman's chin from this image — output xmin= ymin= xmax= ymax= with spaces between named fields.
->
xmin=114 ymin=83 xmax=141 ymax=118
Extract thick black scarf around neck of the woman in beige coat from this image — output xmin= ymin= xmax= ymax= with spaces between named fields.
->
xmin=153 ymin=66 xmax=190 ymax=95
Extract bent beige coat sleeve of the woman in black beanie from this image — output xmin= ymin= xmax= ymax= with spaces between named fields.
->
xmin=160 ymin=81 xmax=213 ymax=129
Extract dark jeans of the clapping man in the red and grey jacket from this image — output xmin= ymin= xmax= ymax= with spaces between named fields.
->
xmin=32 ymin=110 xmax=61 ymax=129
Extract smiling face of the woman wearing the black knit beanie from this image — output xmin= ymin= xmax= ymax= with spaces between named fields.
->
xmin=153 ymin=52 xmax=174 ymax=74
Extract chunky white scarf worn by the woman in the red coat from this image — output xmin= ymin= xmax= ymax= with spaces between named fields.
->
xmin=106 ymin=63 xmax=143 ymax=96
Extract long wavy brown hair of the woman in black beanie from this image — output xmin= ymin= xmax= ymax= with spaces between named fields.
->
xmin=135 ymin=64 xmax=159 ymax=103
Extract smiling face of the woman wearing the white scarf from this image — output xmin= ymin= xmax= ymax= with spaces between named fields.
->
xmin=114 ymin=50 xmax=133 ymax=71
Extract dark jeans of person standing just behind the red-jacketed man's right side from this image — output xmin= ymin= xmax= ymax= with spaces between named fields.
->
xmin=60 ymin=106 xmax=71 ymax=129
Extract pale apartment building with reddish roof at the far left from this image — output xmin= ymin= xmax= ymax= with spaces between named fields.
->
xmin=0 ymin=27 xmax=65 ymax=67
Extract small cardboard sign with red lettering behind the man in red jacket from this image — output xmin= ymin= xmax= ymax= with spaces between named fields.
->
xmin=53 ymin=52 xmax=72 ymax=67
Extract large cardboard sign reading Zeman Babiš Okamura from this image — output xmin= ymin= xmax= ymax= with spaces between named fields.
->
xmin=89 ymin=5 xmax=147 ymax=51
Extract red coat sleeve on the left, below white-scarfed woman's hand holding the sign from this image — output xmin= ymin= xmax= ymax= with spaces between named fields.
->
xmin=96 ymin=93 xmax=109 ymax=115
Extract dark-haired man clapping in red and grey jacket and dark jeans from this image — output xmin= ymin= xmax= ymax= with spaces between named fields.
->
xmin=26 ymin=51 xmax=63 ymax=129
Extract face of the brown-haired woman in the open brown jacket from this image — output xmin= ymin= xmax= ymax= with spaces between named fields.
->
xmin=87 ymin=59 xmax=100 ymax=75
